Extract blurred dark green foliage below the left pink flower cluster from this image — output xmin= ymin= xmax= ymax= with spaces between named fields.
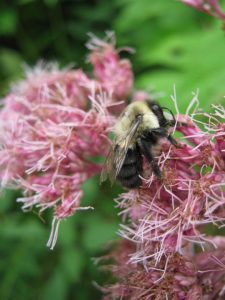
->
xmin=0 ymin=178 xmax=119 ymax=300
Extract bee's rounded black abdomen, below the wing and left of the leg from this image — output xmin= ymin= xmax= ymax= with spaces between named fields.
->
xmin=117 ymin=146 xmax=142 ymax=188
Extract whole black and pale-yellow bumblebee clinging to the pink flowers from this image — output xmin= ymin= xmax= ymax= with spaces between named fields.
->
xmin=101 ymin=100 xmax=178 ymax=188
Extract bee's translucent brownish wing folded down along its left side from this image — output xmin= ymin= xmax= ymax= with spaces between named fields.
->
xmin=100 ymin=118 xmax=142 ymax=182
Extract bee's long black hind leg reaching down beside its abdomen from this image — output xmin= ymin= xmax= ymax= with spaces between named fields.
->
xmin=137 ymin=138 xmax=162 ymax=179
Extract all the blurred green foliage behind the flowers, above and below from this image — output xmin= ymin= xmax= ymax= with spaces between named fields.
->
xmin=0 ymin=0 xmax=225 ymax=300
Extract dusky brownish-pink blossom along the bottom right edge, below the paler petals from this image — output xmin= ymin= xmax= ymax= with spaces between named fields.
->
xmin=100 ymin=238 xmax=225 ymax=300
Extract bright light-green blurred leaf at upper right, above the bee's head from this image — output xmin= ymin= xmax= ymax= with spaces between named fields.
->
xmin=138 ymin=27 xmax=225 ymax=112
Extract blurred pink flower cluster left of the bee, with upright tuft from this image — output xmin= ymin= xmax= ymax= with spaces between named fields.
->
xmin=0 ymin=34 xmax=133 ymax=248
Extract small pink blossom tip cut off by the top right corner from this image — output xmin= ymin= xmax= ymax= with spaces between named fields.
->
xmin=180 ymin=0 xmax=225 ymax=20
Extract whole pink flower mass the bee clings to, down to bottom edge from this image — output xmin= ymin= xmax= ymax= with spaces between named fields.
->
xmin=103 ymin=96 xmax=225 ymax=300
